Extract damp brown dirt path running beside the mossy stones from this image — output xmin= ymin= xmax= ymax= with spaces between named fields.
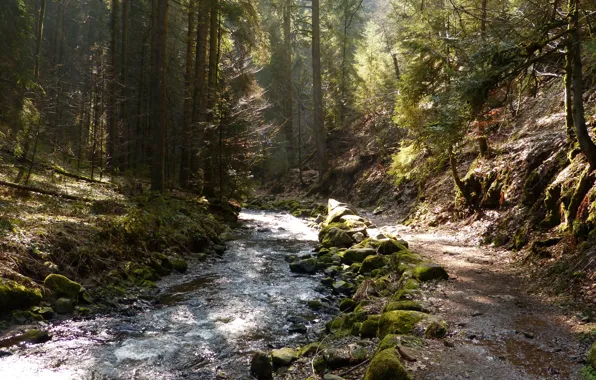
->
xmin=382 ymin=226 xmax=585 ymax=380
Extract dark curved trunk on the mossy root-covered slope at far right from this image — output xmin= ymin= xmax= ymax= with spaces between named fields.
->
xmin=571 ymin=0 xmax=596 ymax=169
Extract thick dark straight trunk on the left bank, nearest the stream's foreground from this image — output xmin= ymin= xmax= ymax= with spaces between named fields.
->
xmin=151 ymin=0 xmax=169 ymax=193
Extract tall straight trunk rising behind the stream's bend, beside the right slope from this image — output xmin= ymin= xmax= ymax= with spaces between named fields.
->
xmin=312 ymin=0 xmax=328 ymax=181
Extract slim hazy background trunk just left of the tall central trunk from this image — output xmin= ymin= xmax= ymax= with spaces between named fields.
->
xmin=283 ymin=0 xmax=295 ymax=168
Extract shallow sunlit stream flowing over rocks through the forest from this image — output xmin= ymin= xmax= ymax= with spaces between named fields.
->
xmin=0 ymin=211 xmax=332 ymax=380
